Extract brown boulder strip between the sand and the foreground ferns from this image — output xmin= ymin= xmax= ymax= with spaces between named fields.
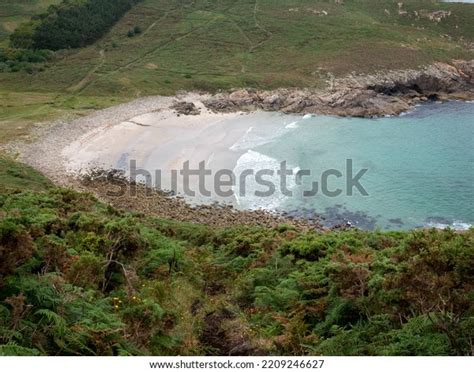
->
xmin=78 ymin=170 xmax=330 ymax=232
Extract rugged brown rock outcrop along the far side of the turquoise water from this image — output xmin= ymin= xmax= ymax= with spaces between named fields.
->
xmin=203 ymin=60 xmax=474 ymax=117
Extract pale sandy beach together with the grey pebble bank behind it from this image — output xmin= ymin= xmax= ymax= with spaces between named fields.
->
xmin=14 ymin=93 xmax=274 ymax=204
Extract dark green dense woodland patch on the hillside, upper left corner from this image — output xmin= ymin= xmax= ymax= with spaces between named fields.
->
xmin=10 ymin=0 xmax=138 ymax=50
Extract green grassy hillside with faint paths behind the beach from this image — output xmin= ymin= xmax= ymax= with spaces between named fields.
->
xmin=0 ymin=0 xmax=474 ymax=142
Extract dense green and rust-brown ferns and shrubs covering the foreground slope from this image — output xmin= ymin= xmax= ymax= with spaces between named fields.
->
xmin=0 ymin=158 xmax=474 ymax=355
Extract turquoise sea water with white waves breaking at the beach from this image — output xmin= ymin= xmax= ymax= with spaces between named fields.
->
xmin=232 ymin=102 xmax=474 ymax=229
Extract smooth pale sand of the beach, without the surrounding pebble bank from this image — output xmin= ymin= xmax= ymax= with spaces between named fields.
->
xmin=60 ymin=99 xmax=258 ymax=203
